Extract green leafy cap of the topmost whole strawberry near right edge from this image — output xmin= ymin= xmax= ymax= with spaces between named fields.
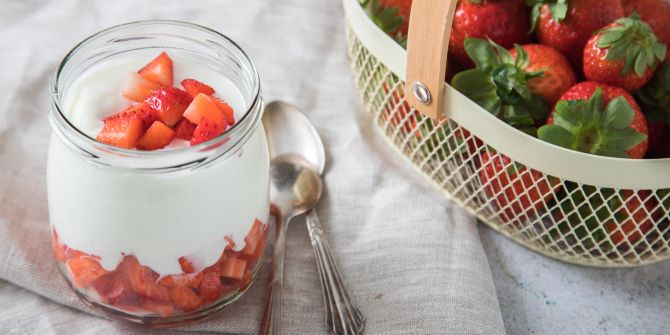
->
xmin=596 ymin=14 xmax=667 ymax=76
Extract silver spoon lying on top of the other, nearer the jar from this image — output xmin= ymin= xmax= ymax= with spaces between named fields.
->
xmin=259 ymin=154 xmax=322 ymax=334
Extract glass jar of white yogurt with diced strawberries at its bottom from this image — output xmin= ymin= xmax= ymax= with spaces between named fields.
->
xmin=47 ymin=21 xmax=269 ymax=326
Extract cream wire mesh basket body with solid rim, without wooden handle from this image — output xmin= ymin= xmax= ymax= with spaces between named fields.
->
xmin=343 ymin=0 xmax=670 ymax=267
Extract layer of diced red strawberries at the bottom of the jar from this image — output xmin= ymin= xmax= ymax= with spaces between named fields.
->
xmin=52 ymin=220 xmax=268 ymax=323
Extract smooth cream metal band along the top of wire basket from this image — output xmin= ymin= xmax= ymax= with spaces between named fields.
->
xmin=342 ymin=0 xmax=670 ymax=190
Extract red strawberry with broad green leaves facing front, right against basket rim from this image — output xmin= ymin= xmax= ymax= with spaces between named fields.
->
xmin=538 ymin=82 xmax=648 ymax=158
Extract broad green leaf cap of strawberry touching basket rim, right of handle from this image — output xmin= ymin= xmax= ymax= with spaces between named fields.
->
xmin=538 ymin=88 xmax=647 ymax=158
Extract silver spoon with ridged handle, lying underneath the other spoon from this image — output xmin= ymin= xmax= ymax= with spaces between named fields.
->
xmin=263 ymin=101 xmax=365 ymax=335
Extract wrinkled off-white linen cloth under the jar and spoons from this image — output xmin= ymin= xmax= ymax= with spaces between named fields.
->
xmin=0 ymin=0 xmax=504 ymax=334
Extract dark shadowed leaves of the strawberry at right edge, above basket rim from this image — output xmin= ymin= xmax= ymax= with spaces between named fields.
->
xmin=635 ymin=60 xmax=670 ymax=127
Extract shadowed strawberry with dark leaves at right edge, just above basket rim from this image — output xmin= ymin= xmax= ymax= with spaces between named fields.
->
xmin=635 ymin=60 xmax=670 ymax=158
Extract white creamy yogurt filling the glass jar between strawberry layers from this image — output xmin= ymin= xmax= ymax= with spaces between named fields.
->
xmin=47 ymin=55 xmax=269 ymax=276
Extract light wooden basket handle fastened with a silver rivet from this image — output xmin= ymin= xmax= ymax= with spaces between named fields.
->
xmin=405 ymin=0 xmax=458 ymax=120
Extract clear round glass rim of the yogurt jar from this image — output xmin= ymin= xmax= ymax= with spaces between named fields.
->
xmin=49 ymin=20 xmax=262 ymax=171
